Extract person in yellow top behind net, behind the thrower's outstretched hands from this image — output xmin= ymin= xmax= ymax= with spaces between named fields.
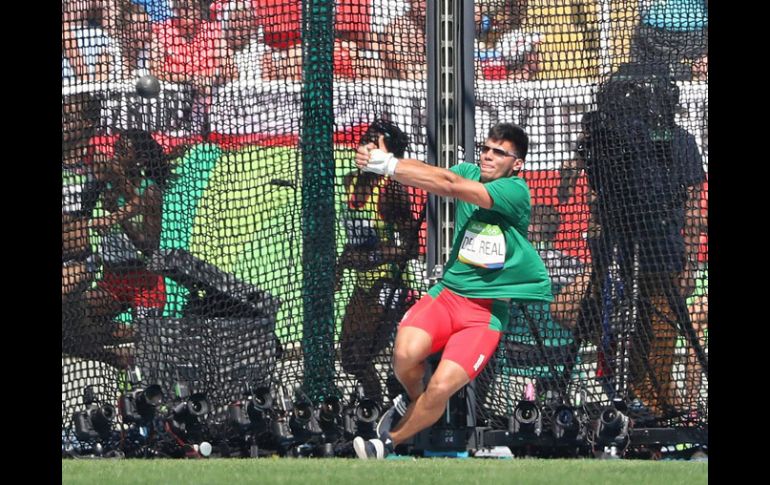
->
xmin=336 ymin=120 xmax=425 ymax=405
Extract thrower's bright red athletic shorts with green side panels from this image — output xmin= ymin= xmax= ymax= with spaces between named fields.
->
xmin=400 ymin=283 xmax=508 ymax=380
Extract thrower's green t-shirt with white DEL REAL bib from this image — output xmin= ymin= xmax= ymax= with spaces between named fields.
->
xmin=442 ymin=163 xmax=553 ymax=301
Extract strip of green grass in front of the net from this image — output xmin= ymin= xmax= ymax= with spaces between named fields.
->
xmin=62 ymin=458 xmax=708 ymax=485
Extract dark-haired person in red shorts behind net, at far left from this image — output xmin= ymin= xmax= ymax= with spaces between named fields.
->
xmin=80 ymin=129 xmax=177 ymax=363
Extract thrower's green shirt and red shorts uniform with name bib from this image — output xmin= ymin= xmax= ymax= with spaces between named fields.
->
xmin=401 ymin=163 xmax=553 ymax=379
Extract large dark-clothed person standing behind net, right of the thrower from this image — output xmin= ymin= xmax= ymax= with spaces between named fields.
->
xmin=560 ymin=64 xmax=705 ymax=418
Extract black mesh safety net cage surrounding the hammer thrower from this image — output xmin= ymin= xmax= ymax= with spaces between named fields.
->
xmin=61 ymin=0 xmax=708 ymax=457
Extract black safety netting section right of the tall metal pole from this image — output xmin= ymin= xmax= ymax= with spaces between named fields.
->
xmin=474 ymin=0 xmax=708 ymax=454
